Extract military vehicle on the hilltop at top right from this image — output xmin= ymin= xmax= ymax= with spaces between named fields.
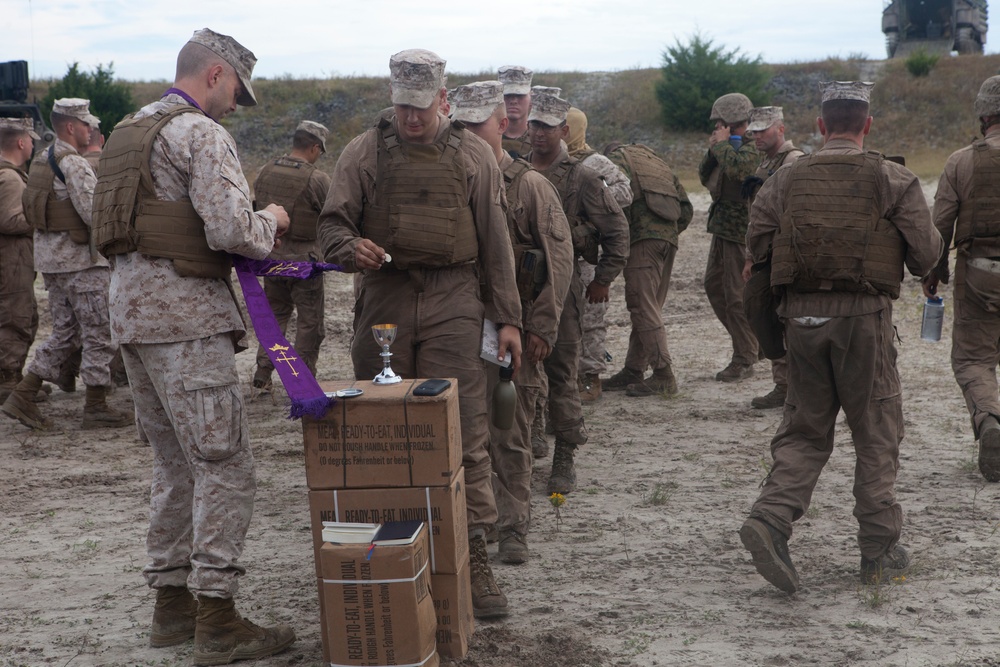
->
xmin=882 ymin=0 xmax=986 ymax=58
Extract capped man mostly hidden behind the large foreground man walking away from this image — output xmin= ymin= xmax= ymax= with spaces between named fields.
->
xmin=743 ymin=107 xmax=805 ymax=410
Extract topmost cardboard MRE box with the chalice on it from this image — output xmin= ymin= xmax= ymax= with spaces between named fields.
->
xmin=302 ymin=379 xmax=462 ymax=489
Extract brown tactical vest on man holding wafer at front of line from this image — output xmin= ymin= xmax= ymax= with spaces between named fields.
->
xmin=361 ymin=119 xmax=479 ymax=269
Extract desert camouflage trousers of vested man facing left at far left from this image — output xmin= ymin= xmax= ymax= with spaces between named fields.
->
xmin=28 ymin=266 xmax=118 ymax=387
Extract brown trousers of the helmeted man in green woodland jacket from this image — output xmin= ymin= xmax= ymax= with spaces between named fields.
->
xmin=705 ymin=234 xmax=758 ymax=365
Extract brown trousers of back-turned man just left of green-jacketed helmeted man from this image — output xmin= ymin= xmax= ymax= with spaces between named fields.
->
xmin=624 ymin=239 xmax=677 ymax=373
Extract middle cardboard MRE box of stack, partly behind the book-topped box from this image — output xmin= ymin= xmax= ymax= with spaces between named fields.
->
xmin=309 ymin=468 xmax=469 ymax=576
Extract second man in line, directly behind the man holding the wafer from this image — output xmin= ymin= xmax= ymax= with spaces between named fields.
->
xmin=452 ymin=81 xmax=573 ymax=564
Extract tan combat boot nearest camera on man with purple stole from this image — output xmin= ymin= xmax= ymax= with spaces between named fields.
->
xmin=194 ymin=596 xmax=294 ymax=665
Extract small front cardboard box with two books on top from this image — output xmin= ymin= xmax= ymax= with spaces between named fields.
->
xmin=320 ymin=525 xmax=438 ymax=667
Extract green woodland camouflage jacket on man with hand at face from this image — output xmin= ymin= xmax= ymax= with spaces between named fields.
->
xmin=698 ymin=141 xmax=760 ymax=245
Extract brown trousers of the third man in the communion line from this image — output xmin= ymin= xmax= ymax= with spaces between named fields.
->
xmin=542 ymin=271 xmax=587 ymax=445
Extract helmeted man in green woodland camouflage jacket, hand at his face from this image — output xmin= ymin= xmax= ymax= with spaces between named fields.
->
xmin=698 ymin=93 xmax=760 ymax=382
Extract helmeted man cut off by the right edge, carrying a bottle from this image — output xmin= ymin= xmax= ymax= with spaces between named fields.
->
xmin=924 ymin=76 xmax=1000 ymax=482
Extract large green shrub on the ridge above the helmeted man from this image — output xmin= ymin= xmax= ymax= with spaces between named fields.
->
xmin=656 ymin=34 xmax=770 ymax=130
